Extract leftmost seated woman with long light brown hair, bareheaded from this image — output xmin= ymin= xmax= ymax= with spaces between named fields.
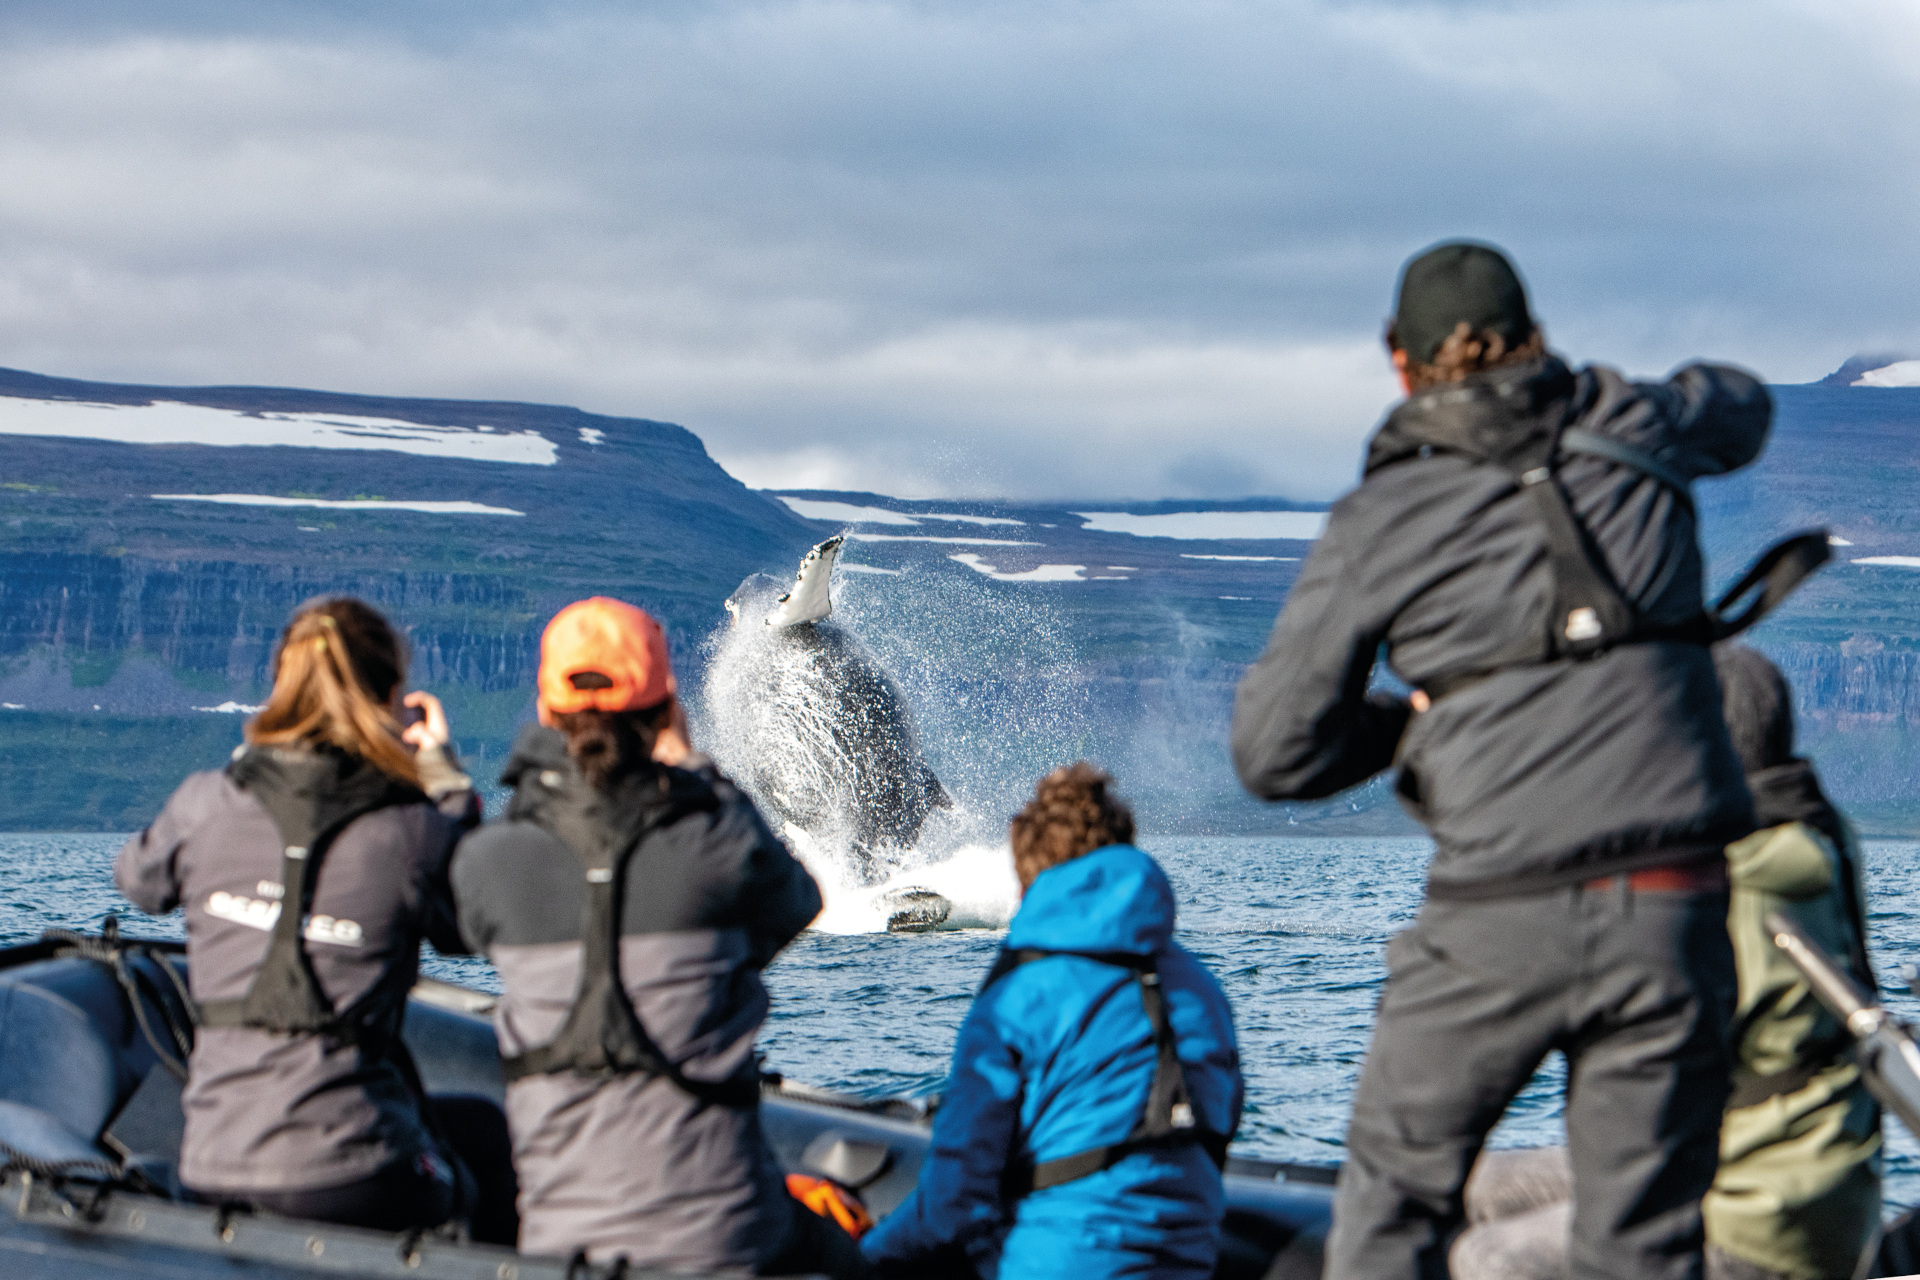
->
xmin=113 ymin=599 xmax=515 ymax=1240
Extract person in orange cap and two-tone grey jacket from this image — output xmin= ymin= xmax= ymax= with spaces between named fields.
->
xmin=453 ymin=597 xmax=864 ymax=1278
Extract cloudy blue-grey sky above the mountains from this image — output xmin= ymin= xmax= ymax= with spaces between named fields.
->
xmin=0 ymin=0 xmax=1920 ymax=501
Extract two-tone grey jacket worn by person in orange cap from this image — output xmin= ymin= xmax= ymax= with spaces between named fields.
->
xmin=453 ymin=725 xmax=820 ymax=1270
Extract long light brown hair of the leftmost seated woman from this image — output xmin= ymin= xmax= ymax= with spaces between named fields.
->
xmin=246 ymin=597 xmax=420 ymax=787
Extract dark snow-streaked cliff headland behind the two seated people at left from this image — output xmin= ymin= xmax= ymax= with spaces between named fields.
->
xmin=0 ymin=370 xmax=818 ymax=829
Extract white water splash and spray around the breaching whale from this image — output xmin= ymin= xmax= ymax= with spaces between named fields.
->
xmin=693 ymin=562 xmax=1089 ymax=933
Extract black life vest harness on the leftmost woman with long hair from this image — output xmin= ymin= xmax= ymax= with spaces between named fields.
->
xmin=198 ymin=747 xmax=426 ymax=1055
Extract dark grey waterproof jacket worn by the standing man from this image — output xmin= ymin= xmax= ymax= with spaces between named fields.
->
xmin=1233 ymin=357 xmax=1772 ymax=898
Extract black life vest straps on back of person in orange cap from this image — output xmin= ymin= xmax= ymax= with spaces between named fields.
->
xmin=501 ymin=779 xmax=760 ymax=1107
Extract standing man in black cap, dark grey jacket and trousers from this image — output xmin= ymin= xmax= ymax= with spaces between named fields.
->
xmin=1233 ymin=244 xmax=1772 ymax=1278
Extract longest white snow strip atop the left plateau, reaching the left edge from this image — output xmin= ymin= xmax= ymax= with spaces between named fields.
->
xmin=0 ymin=395 xmax=559 ymax=466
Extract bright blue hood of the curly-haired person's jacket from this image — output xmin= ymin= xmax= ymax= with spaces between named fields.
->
xmin=1006 ymin=844 xmax=1173 ymax=956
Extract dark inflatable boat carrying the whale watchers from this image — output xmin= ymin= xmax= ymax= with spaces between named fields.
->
xmin=0 ymin=921 xmax=1332 ymax=1280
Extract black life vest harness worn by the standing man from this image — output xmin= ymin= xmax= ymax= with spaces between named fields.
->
xmin=1367 ymin=367 xmax=1832 ymax=700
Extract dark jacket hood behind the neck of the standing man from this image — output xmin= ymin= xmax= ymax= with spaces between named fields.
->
xmin=1367 ymin=355 xmax=1574 ymax=474
